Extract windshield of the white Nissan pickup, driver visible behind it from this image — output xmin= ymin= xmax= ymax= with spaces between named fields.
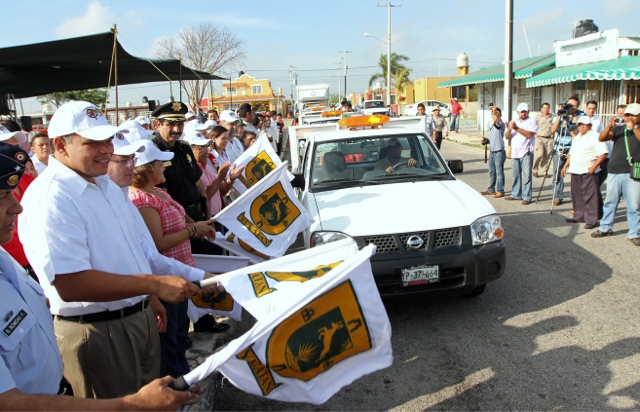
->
xmin=311 ymin=134 xmax=452 ymax=191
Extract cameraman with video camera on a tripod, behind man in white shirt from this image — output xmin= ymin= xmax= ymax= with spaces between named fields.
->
xmin=551 ymin=96 xmax=585 ymax=206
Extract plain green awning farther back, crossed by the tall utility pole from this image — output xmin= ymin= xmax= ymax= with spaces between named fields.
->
xmin=438 ymin=54 xmax=556 ymax=88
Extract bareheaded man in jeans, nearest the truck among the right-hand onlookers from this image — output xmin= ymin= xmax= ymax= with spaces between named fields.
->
xmin=480 ymin=107 xmax=507 ymax=198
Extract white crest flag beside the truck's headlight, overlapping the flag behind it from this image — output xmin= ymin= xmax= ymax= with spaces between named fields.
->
xmin=213 ymin=162 xmax=313 ymax=257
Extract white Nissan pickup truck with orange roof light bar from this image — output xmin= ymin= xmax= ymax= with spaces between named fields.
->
xmin=289 ymin=116 xmax=506 ymax=296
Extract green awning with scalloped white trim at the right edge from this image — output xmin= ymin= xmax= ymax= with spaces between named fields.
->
xmin=527 ymin=56 xmax=640 ymax=87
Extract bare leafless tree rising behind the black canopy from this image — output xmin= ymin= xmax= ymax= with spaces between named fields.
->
xmin=156 ymin=23 xmax=246 ymax=112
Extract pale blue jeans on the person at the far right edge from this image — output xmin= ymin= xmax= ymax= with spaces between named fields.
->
xmin=600 ymin=173 xmax=640 ymax=239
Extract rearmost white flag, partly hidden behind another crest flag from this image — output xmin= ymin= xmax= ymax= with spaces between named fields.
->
xmin=233 ymin=135 xmax=293 ymax=194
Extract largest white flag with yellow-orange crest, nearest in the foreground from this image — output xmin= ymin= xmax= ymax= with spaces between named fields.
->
xmin=184 ymin=245 xmax=393 ymax=404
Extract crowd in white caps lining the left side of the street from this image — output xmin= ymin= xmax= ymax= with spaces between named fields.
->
xmin=0 ymin=101 xmax=284 ymax=410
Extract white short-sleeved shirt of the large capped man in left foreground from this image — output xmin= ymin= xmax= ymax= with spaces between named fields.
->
xmin=18 ymin=157 xmax=152 ymax=316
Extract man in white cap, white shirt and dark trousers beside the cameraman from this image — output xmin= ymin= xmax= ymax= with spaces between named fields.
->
xmin=562 ymin=116 xmax=609 ymax=229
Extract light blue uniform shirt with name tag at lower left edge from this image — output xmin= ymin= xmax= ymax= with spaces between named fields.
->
xmin=0 ymin=248 xmax=62 ymax=395
